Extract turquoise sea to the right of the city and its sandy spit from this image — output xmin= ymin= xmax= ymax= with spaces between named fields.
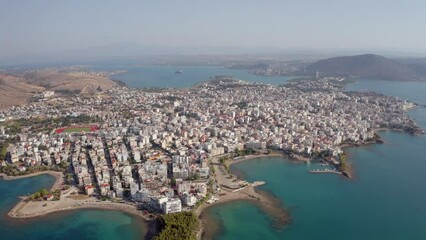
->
xmin=208 ymin=81 xmax=426 ymax=240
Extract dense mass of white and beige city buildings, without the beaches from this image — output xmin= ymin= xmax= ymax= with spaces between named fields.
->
xmin=0 ymin=79 xmax=419 ymax=213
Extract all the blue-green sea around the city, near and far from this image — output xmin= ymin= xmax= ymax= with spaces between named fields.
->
xmin=0 ymin=64 xmax=426 ymax=240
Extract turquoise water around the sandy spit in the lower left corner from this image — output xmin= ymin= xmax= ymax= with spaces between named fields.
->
xmin=0 ymin=175 xmax=146 ymax=240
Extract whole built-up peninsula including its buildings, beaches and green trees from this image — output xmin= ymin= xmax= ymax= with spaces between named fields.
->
xmin=0 ymin=72 xmax=424 ymax=239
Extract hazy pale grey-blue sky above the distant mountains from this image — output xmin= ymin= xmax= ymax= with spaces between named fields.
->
xmin=0 ymin=0 xmax=426 ymax=57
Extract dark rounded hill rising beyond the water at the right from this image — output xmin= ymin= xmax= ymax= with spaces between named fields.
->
xmin=305 ymin=54 xmax=426 ymax=81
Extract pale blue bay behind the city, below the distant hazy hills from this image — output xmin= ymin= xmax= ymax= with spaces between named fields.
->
xmin=91 ymin=65 xmax=291 ymax=88
